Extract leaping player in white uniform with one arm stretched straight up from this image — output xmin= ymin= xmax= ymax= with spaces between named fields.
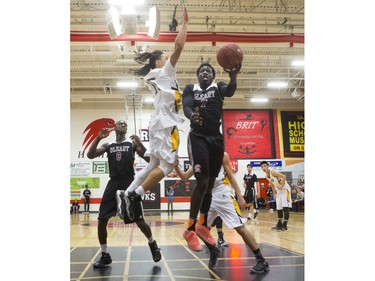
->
xmin=118 ymin=6 xmax=189 ymax=219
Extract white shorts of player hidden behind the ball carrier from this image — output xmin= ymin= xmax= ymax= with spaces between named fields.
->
xmin=207 ymin=187 xmax=243 ymax=228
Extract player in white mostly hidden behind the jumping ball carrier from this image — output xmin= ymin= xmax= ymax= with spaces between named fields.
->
xmin=175 ymin=152 xmax=269 ymax=273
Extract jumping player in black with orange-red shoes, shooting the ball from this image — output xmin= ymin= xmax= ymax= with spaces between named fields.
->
xmin=182 ymin=63 xmax=241 ymax=251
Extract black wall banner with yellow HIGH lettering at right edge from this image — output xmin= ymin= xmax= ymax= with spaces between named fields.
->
xmin=280 ymin=111 xmax=305 ymax=157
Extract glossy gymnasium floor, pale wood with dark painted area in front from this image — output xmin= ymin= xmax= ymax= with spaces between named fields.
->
xmin=70 ymin=210 xmax=305 ymax=281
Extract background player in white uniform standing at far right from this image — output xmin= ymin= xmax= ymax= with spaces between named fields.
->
xmin=260 ymin=161 xmax=292 ymax=231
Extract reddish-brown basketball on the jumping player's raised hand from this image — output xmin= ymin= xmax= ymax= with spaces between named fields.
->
xmin=216 ymin=43 xmax=243 ymax=69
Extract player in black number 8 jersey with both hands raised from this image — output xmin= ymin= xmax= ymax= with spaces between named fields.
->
xmin=87 ymin=120 xmax=161 ymax=268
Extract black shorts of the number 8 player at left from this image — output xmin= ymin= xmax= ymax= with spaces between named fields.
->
xmin=98 ymin=177 xmax=134 ymax=219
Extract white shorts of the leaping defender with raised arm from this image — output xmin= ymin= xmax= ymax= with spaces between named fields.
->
xmin=145 ymin=126 xmax=180 ymax=164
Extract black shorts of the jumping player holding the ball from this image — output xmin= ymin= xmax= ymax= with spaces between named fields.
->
xmin=188 ymin=131 xmax=224 ymax=178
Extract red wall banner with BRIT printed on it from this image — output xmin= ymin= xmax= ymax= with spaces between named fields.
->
xmin=223 ymin=110 xmax=275 ymax=159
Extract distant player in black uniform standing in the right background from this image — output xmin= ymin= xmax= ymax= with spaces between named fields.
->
xmin=243 ymin=164 xmax=260 ymax=220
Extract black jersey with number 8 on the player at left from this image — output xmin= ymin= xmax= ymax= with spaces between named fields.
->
xmin=107 ymin=139 xmax=135 ymax=179
